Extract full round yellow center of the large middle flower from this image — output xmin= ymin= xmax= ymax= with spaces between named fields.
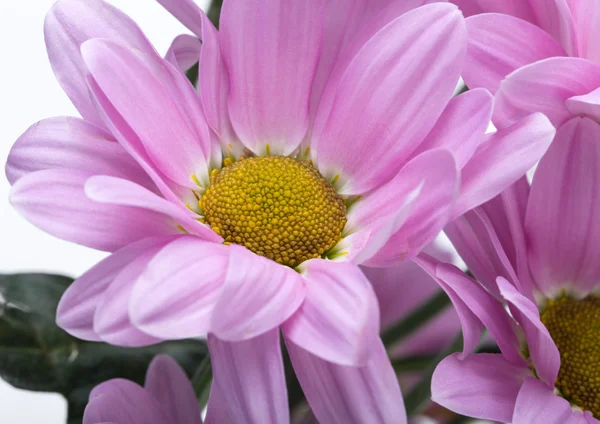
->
xmin=200 ymin=156 xmax=346 ymax=266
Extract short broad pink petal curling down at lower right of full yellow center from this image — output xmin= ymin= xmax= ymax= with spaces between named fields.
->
xmin=282 ymin=259 xmax=379 ymax=365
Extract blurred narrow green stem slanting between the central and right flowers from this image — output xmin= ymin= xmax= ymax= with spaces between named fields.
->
xmin=381 ymin=291 xmax=450 ymax=347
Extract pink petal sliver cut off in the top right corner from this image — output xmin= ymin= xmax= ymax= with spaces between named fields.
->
xmin=571 ymin=0 xmax=600 ymax=63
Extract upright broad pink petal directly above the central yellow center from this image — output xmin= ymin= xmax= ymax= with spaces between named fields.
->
xmin=221 ymin=0 xmax=325 ymax=155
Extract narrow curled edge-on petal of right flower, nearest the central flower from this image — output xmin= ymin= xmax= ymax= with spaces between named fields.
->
xmin=414 ymin=252 xmax=483 ymax=357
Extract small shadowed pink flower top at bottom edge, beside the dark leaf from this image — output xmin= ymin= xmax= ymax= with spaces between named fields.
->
xmin=83 ymin=355 xmax=206 ymax=424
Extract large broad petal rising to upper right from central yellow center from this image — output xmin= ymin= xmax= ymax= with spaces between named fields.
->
xmin=311 ymin=3 xmax=466 ymax=194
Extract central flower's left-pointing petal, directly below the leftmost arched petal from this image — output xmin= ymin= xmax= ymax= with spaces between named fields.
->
xmin=10 ymin=169 xmax=180 ymax=251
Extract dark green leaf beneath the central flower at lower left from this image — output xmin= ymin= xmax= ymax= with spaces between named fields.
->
xmin=0 ymin=274 xmax=208 ymax=422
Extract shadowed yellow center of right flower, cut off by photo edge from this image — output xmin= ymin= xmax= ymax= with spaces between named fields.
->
xmin=541 ymin=296 xmax=600 ymax=417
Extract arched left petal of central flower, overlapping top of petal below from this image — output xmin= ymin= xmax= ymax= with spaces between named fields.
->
xmin=6 ymin=117 xmax=153 ymax=188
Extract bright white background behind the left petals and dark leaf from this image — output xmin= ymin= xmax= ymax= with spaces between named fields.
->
xmin=0 ymin=0 xmax=208 ymax=424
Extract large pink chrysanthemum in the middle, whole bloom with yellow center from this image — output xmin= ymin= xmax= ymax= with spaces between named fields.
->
xmin=6 ymin=0 xmax=554 ymax=423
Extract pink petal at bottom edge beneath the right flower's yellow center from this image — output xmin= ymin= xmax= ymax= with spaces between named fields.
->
xmin=511 ymin=377 xmax=588 ymax=424
